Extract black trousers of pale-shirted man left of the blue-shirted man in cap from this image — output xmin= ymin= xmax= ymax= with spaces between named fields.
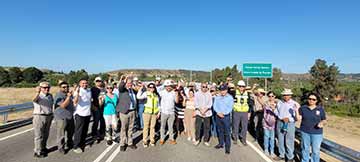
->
xmin=195 ymin=115 xmax=211 ymax=142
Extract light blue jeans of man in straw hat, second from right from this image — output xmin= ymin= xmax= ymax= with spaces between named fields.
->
xmin=276 ymin=120 xmax=295 ymax=160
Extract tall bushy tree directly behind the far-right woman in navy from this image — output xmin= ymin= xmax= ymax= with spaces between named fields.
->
xmin=309 ymin=59 xmax=339 ymax=101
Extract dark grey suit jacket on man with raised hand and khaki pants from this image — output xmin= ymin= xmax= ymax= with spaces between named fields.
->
xmin=116 ymin=81 xmax=137 ymax=114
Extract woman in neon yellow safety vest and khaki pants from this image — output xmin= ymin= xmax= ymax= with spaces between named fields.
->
xmin=137 ymin=83 xmax=160 ymax=148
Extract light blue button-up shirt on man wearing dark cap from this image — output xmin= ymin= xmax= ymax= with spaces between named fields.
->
xmin=214 ymin=94 xmax=234 ymax=115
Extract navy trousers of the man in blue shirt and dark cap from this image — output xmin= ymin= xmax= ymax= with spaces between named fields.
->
xmin=216 ymin=115 xmax=231 ymax=151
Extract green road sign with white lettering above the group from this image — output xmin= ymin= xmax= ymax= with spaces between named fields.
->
xmin=242 ymin=63 xmax=272 ymax=78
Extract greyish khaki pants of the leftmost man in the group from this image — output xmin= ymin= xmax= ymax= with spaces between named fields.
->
xmin=33 ymin=115 xmax=53 ymax=154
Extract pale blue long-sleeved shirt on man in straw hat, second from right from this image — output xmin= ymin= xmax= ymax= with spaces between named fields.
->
xmin=275 ymin=99 xmax=300 ymax=122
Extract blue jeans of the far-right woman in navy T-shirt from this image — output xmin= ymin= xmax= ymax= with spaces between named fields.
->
xmin=301 ymin=132 xmax=323 ymax=162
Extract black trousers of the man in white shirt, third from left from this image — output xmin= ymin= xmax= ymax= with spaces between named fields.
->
xmin=74 ymin=114 xmax=91 ymax=149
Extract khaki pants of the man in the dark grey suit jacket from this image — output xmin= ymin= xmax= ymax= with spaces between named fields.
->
xmin=119 ymin=111 xmax=136 ymax=146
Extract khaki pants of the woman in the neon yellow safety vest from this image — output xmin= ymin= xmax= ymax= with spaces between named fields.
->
xmin=143 ymin=113 xmax=157 ymax=143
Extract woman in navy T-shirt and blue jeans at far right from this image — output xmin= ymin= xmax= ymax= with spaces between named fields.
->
xmin=299 ymin=93 xmax=326 ymax=162
